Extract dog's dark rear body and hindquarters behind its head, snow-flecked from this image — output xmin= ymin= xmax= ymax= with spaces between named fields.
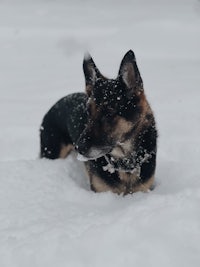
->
xmin=40 ymin=93 xmax=87 ymax=159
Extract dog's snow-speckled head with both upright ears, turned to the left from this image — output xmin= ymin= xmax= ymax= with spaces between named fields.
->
xmin=76 ymin=50 xmax=145 ymax=159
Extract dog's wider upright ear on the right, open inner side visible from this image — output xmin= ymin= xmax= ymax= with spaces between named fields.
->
xmin=118 ymin=50 xmax=143 ymax=93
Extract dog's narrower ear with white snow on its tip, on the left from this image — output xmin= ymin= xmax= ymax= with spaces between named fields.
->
xmin=83 ymin=53 xmax=103 ymax=96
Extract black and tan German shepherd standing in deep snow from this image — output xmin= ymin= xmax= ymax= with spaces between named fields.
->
xmin=40 ymin=50 xmax=157 ymax=195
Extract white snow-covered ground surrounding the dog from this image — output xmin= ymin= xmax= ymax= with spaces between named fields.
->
xmin=0 ymin=0 xmax=200 ymax=267
